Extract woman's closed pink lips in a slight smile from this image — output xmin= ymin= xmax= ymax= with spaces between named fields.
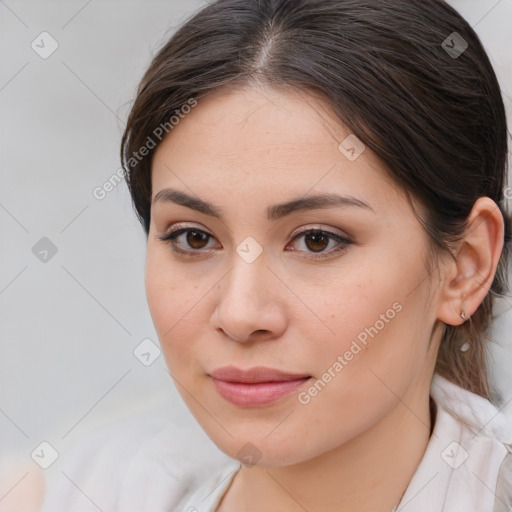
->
xmin=210 ymin=366 xmax=311 ymax=407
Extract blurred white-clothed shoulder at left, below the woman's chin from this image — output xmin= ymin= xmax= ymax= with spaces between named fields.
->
xmin=43 ymin=412 xmax=230 ymax=512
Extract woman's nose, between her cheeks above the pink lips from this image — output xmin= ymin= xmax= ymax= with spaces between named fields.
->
xmin=210 ymin=255 xmax=288 ymax=343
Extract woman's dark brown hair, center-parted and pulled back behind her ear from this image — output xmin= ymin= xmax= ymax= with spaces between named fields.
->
xmin=121 ymin=0 xmax=509 ymax=397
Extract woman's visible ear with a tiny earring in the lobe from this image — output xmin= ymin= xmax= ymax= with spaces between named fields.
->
xmin=438 ymin=197 xmax=504 ymax=325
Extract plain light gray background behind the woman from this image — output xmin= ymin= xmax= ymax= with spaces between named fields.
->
xmin=0 ymin=0 xmax=512 ymax=482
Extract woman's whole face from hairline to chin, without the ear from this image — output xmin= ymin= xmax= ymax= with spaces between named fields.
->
xmin=146 ymin=88 xmax=439 ymax=466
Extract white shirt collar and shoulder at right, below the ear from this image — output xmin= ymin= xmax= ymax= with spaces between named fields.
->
xmin=400 ymin=374 xmax=512 ymax=512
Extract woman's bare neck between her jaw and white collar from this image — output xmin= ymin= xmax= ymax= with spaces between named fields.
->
xmin=217 ymin=376 xmax=431 ymax=512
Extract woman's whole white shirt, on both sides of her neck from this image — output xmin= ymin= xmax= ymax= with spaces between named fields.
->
xmin=43 ymin=374 xmax=512 ymax=512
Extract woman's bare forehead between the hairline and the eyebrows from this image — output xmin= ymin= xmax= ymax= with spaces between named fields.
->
xmin=152 ymin=87 xmax=398 ymax=210
